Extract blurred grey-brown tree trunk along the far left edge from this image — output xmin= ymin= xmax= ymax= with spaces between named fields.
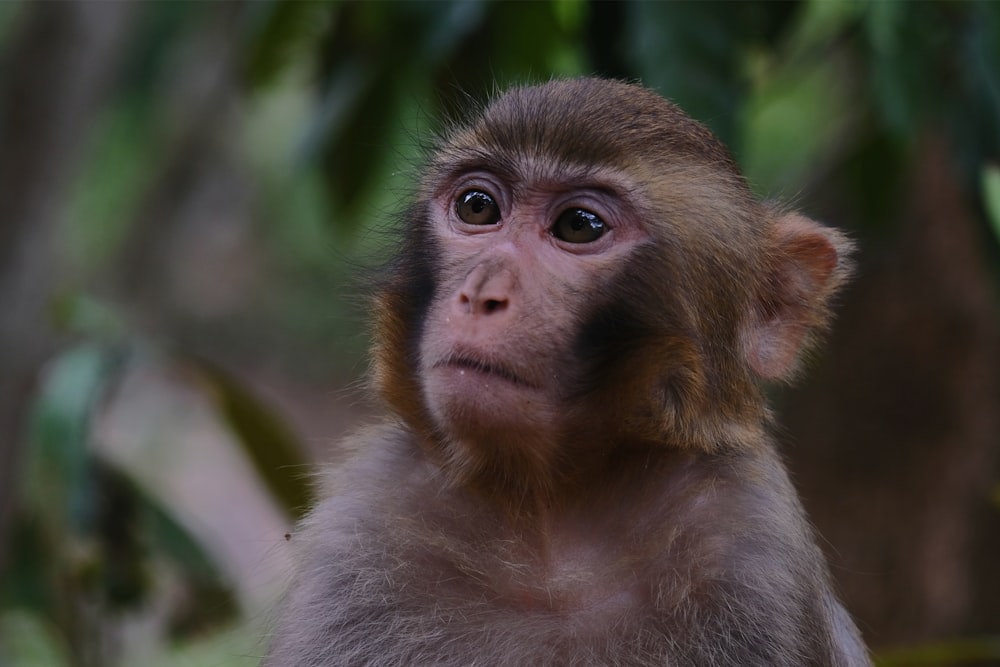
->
xmin=0 ymin=2 xmax=133 ymax=566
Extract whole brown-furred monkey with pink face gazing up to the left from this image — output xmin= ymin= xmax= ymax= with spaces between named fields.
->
xmin=265 ymin=79 xmax=869 ymax=667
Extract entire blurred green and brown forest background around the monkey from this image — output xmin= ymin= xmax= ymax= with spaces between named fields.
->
xmin=0 ymin=0 xmax=1000 ymax=667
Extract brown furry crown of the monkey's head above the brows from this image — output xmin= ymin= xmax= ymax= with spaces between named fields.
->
xmin=443 ymin=78 xmax=740 ymax=181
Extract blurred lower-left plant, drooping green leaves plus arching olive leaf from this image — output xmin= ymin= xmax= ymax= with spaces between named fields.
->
xmin=0 ymin=297 xmax=309 ymax=665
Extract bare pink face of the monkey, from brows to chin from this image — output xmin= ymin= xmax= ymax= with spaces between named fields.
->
xmin=419 ymin=162 xmax=648 ymax=448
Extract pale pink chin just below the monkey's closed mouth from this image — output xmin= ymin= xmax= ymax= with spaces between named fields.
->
xmin=423 ymin=364 xmax=553 ymax=439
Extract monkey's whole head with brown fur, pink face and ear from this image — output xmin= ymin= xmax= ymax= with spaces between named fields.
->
xmin=375 ymin=79 xmax=849 ymax=496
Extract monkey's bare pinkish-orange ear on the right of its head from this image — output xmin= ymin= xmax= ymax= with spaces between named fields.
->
xmin=744 ymin=213 xmax=852 ymax=380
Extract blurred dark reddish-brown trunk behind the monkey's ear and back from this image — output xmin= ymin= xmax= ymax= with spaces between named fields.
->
xmin=784 ymin=138 xmax=1000 ymax=648
